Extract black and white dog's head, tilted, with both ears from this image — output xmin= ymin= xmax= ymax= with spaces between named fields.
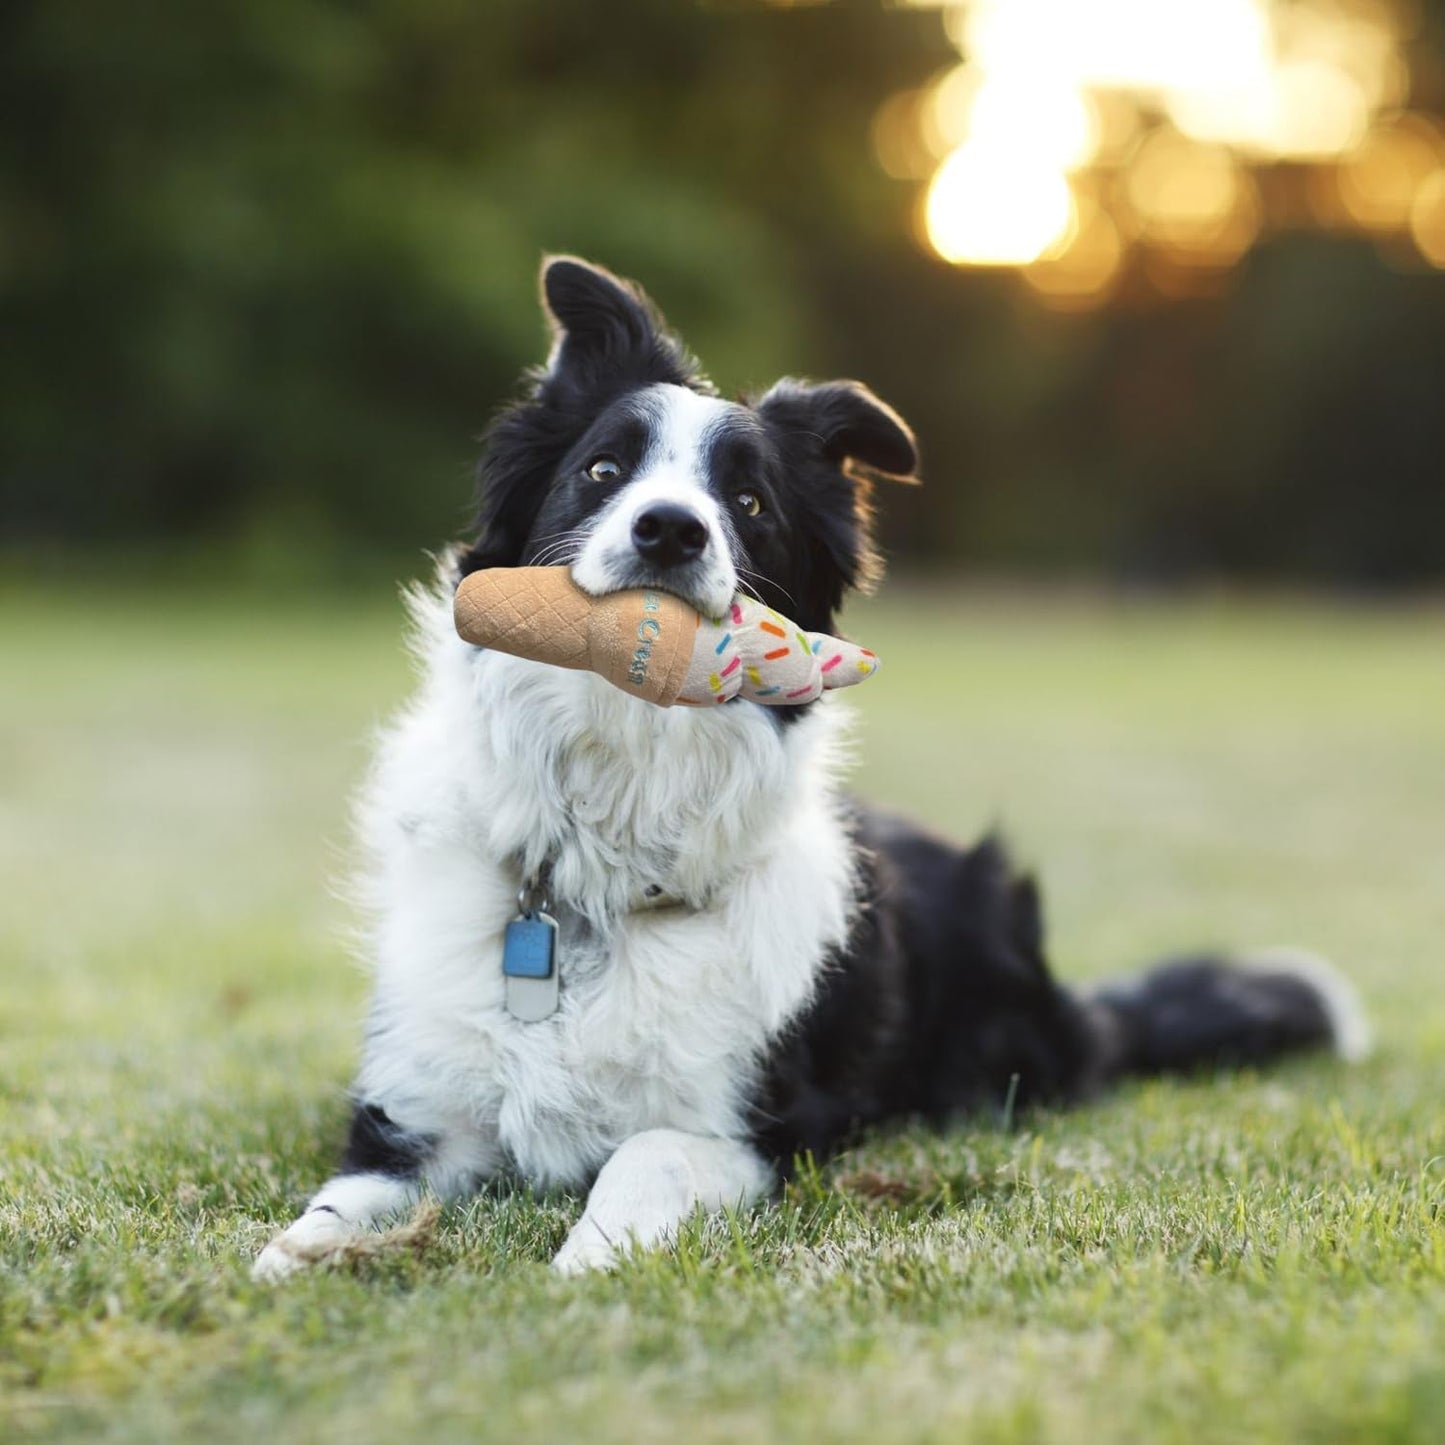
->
xmin=461 ymin=257 xmax=918 ymax=631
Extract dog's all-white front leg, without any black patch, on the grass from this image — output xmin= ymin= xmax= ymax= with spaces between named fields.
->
xmin=552 ymin=1129 xmax=773 ymax=1274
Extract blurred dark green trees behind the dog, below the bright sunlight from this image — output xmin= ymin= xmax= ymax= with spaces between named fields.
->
xmin=8 ymin=0 xmax=1445 ymax=587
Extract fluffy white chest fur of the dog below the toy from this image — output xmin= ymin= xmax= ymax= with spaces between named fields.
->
xmin=346 ymin=580 xmax=853 ymax=1183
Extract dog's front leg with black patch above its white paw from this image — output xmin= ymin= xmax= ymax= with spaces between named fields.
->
xmin=251 ymin=1104 xmax=491 ymax=1283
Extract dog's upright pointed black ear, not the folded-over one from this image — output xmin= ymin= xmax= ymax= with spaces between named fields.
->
xmin=542 ymin=256 xmax=698 ymax=392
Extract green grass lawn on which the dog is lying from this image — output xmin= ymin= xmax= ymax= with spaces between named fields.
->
xmin=0 ymin=592 xmax=1445 ymax=1445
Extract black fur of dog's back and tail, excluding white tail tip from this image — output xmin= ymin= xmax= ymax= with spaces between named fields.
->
xmin=754 ymin=812 xmax=1345 ymax=1169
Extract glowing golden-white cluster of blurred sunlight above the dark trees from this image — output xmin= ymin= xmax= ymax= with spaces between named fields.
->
xmin=874 ymin=0 xmax=1445 ymax=309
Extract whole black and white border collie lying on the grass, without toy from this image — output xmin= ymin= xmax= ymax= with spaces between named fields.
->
xmin=256 ymin=257 xmax=1363 ymax=1279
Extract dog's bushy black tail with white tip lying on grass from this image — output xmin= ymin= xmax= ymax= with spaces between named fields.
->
xmin=1079 ymin=948 xmax=1370 ymax=1082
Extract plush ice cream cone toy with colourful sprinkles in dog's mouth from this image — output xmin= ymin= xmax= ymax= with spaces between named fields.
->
xmin=455 ymin=566 xmax=879 ymax=708
